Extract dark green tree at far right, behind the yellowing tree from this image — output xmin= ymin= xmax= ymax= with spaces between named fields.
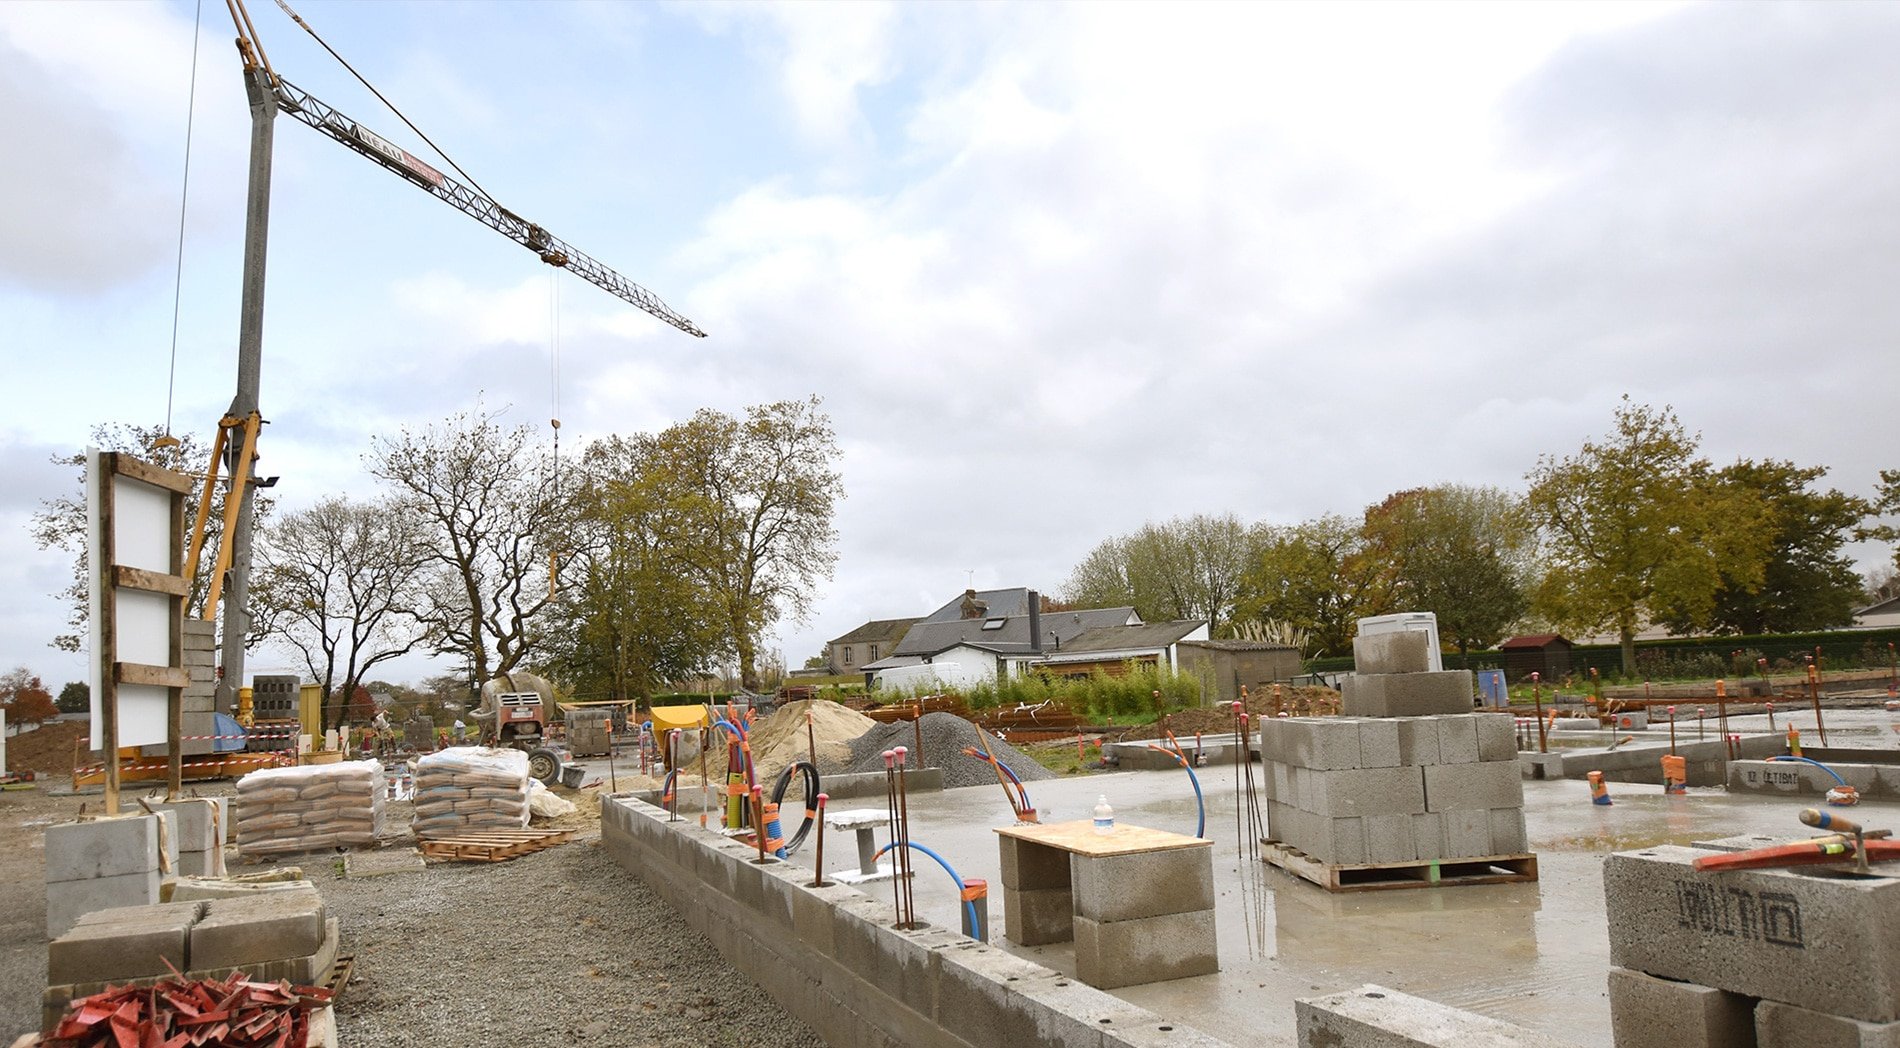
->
xmin=1664 ymin=459 xmax=1873 ymax=636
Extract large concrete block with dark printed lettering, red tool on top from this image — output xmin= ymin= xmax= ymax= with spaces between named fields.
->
xmin=1604 ymin=845 xmax=1900 ymax=1023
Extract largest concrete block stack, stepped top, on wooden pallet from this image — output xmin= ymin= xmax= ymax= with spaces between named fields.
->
xmin=1260 ymin=632 xmax=1530 ymax=866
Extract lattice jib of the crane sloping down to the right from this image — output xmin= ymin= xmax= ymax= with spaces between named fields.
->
xmin=276 ymin=76 xmax=705 ymax=338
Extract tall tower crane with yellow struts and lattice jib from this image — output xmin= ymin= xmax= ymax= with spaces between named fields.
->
xmin=184 ymin=0 xmax=705 ymax=708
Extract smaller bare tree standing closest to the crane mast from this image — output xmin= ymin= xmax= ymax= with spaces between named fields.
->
xmin=253 ymin=497 xmax=429 ymax=725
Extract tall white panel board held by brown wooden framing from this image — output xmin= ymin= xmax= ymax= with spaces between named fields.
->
xmin=86 ymin=448 xmax=179 ymax=750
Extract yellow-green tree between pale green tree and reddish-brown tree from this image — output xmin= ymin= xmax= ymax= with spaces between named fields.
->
xmin=1235 ymin=515 xmax=1398 ymax=655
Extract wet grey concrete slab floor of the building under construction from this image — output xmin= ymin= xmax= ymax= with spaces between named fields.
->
xmin=771 ymin=710 xmax=1900 ymax=1048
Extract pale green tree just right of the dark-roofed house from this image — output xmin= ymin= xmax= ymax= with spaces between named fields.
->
xmin=1062 ymin=513 xmax=1260 ymax=628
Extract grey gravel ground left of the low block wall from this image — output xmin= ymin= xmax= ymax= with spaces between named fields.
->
xmin=0 ymin=790 xmax=823 ymax=1048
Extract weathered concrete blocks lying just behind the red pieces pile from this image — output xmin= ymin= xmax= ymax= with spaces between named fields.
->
xmin=40 ymin=883 xmax=336 ymax=1029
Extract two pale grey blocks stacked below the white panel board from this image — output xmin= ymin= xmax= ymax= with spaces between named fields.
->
xmin=46 ymin=811 xmax=179 ymax=938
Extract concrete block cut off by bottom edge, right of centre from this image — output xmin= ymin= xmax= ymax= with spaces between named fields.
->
xmin=1294 ymin=983 xmax=1580 ymax=1048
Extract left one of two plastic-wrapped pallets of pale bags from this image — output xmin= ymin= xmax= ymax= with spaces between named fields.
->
xmin=236 ymin=761 xmax=384 ymax=854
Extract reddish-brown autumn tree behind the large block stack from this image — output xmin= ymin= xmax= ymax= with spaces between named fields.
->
xmin=1366 ymin=484 xmax=1533 ymax=653
